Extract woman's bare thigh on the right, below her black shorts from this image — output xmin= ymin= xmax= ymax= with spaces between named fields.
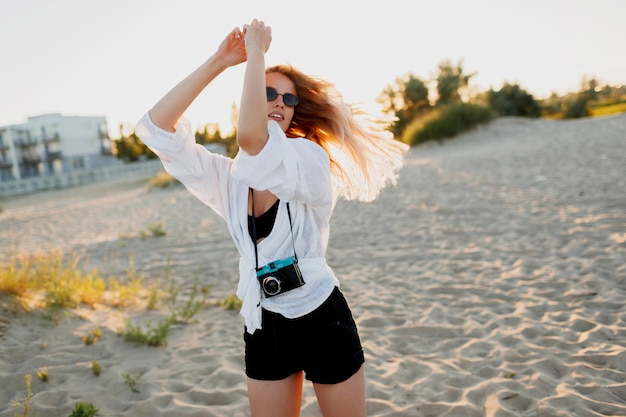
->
xmin=313 ymin=366 xmax=367 ymax=417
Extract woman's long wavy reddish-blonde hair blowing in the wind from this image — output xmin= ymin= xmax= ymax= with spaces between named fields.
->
xmin=265 ymin=65 xmax=408 ymax=201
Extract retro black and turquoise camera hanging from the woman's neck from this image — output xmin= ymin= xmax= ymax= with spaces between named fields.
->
xmin=256 ymin=256 xmax=304 ymax=297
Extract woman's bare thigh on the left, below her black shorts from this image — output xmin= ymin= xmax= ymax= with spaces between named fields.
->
xmin=248 ymin=372 xmax=303 ymax=417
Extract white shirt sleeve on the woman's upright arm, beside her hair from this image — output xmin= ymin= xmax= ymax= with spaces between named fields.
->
xmin=231 ymin=120 xmax=333 ymax=205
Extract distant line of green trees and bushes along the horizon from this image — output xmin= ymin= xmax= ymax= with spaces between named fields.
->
xmin=114 ymin=60 xmax=626 ymax=161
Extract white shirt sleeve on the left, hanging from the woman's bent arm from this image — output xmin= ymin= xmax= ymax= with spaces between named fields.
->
xmin=135 ymin=113 xmax=232 ymax=218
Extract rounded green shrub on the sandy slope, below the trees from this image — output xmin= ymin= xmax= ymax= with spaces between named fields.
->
xmin=402 ymin=103 xmax=495 ymax=146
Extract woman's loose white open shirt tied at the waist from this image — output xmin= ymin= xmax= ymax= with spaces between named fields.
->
xmin=135 ymin=114 xmax=339 ymax=334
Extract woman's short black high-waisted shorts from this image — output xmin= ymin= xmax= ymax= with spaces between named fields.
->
xmin=244 ymin=288 xmax=365 ymax=384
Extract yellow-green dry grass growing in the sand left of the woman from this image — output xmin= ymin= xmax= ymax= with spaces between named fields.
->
xmin=0 ymin=247 xmax=236 ymax=348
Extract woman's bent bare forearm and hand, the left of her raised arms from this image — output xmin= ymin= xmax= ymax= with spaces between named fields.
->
xmin=149 ymin=28 xmax=247 ymax=132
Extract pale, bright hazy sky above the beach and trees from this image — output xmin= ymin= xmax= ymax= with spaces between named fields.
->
xmin=0 ymin=0 xmax=626 ymax=138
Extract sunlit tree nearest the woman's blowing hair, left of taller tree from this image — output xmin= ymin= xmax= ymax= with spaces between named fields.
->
xmin=377 ymin=73 xmax=431 ymax=137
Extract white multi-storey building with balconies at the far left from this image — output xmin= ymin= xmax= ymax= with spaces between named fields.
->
xmin=0 ymin=114 xmax=113 ymax=182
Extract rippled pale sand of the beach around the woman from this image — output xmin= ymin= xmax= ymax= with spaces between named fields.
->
xmin=0 ymin=114 xmax=626 ymax=417
